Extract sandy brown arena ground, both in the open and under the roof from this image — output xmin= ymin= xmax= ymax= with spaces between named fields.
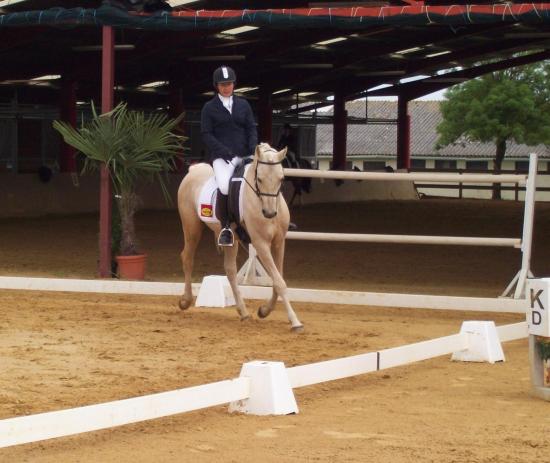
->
xmin=0 ymin=200 xmax=550 ymax=463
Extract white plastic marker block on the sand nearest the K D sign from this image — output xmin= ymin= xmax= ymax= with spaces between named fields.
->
xmin=451 ymin=321 xmax=504 ymax=363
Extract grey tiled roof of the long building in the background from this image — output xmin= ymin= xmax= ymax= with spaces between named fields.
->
xmin=317 ymin=101 xmax=550 ymax=159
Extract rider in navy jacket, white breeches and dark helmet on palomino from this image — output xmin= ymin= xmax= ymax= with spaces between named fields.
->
xmin=201 ymin=66 xmax=258 ymax=246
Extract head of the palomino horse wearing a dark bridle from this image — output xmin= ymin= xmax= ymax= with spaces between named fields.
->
xmin=254 ymin=143 xmax=286 ymax=219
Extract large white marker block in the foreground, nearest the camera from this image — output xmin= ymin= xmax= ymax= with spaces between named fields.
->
xmin=229 ymin=360 xmax=298 ymax=415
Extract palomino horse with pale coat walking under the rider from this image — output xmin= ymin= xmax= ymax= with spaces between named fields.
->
xmin=178 ymin=143 xmax=303 ymax=331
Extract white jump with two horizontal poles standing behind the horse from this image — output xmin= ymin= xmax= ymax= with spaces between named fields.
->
xmin=244 ymin=153 xmax=538 ymax=299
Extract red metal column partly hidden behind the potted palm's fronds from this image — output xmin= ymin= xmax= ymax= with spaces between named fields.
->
xmin=99 ymin=26 xmax=115 ymax=278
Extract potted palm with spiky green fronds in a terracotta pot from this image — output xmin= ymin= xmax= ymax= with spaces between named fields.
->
xmin=53 ymin=103 xmax=185 ymax=279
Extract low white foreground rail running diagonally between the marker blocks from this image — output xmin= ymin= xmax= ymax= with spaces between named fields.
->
xmin=0 ymin=322 xmax=527 ymax=448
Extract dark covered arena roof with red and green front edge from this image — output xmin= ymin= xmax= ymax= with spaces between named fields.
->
xmin=0 ymin=0 xmax=550 ymax=113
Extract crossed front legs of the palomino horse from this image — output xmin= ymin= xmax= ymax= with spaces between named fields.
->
xmin=256 ymin=238 xmax=304 ymax=332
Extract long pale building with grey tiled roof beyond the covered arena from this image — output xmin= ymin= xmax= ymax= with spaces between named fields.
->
xmin=316 ymin=100 xmax=550 ymax=200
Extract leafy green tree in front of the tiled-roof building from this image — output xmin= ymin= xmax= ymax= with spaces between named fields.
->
xmin=437 ymin=62 xmax=550 ymax=197
